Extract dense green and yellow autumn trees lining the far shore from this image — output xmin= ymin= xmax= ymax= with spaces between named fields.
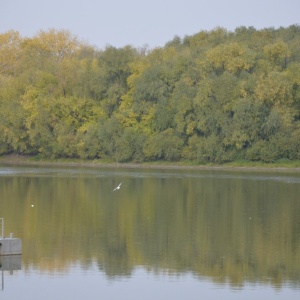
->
xmin=0 ymin=25 xmax=300 ymax=164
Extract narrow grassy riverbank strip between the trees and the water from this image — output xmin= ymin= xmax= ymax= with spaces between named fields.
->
xmin=0 ymin=154 xmax=300 ymax=172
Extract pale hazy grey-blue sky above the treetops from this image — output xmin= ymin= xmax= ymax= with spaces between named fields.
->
xmin=0 ymin=0 xmax=300 ymax=48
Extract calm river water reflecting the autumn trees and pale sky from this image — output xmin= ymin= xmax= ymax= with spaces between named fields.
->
xmin=0 ymin=165 xmax=300 ymax=300
